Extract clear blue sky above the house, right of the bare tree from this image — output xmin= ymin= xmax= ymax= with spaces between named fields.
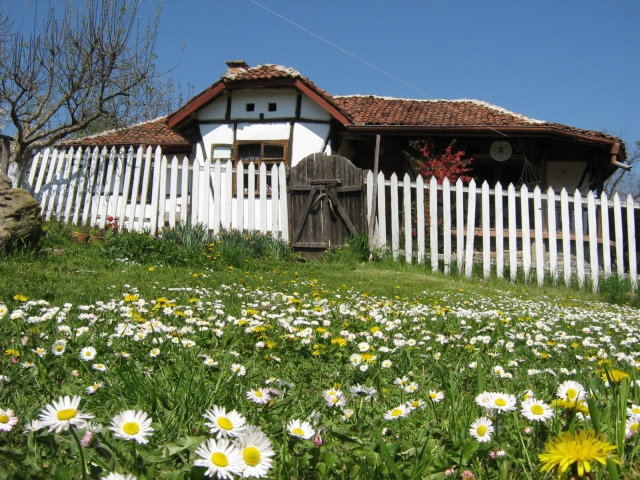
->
xmin=157 ymin=0 xmax=640 ymax=152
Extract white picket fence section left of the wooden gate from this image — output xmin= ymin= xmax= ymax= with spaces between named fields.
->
xmin=18 ymin=143 xmax=289 ymax=241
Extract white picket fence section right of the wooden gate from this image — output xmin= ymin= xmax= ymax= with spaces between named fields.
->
xmin=366 ymin=171 xmax=640 ymax=291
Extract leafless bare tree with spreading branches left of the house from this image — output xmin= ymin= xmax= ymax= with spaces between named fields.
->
xmin=0 ymin=0 xmax=168 ymax=171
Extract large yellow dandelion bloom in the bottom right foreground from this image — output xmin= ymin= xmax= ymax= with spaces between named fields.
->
xmin=538 ymin=430 xmax=621 ymax=478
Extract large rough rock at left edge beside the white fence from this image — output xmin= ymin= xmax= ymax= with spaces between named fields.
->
xmin=0 ymin=173 xmax=44 ymax=250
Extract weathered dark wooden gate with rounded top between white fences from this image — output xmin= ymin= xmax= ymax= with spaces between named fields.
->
xmin=289 ymin=153 xmax=366 ymax=258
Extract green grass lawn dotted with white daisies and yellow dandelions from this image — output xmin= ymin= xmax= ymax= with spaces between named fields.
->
xmin=0 ymin=224 xmax=640 ymax=479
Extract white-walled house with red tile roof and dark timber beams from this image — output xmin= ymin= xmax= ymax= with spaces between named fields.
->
xmin=64 ymin=61 xmax=629 ymax=192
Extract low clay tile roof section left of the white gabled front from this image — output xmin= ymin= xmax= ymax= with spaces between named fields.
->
xmin=61 ymin=117 xmax=191 ymax=147
